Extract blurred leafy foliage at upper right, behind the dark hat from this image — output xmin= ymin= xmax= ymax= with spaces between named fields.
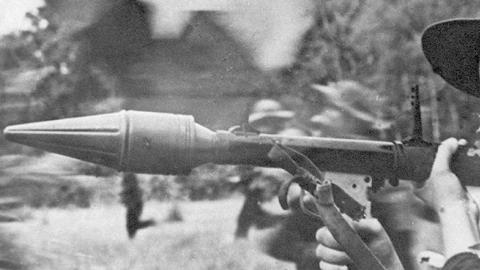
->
xmin=277 ymin=0 xmax=480 ymax=140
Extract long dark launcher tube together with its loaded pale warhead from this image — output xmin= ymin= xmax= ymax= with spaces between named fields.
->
xmin=4 ymin=108 xmax=480 ymax=185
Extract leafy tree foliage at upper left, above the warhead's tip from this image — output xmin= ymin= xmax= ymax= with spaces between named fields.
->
xmin=0 ymin=6 xmax=112 ymax=121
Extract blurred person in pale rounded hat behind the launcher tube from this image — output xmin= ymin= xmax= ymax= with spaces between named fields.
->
xmin=235 ymin=99 xmax=321 ymax=270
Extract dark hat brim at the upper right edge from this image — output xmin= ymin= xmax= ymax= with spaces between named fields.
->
xmin=422 ymin=19 xmax=480 ymax=97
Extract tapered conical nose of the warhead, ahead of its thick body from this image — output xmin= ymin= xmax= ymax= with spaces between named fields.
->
xmin=4 ymin=112 xmax=127 ymax=169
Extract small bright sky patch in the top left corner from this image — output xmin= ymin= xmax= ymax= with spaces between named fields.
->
xmin=0 ymin=0 xmax=45 ymax=36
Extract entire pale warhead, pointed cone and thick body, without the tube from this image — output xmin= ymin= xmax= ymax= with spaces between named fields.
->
xmin=4 ymin=111 xmax=215 ymax=174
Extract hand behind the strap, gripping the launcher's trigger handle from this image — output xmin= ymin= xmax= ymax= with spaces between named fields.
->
xmin=316 ymin=218 xmax=403 ymax=270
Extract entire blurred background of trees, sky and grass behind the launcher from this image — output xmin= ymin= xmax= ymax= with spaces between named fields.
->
xmin=0 ymin=0 xmax=480 ymax=270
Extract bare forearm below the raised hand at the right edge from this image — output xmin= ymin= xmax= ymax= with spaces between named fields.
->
xmin=438 ymin=200 xmax=479 ymax=258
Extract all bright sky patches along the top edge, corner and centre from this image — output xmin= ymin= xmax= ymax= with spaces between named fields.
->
xmin=0 ymin=0 xmax=316 ymax=69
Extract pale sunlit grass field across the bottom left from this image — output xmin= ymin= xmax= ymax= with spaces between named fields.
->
xmin=0 ymin=199 xmax=294 ymax=270
